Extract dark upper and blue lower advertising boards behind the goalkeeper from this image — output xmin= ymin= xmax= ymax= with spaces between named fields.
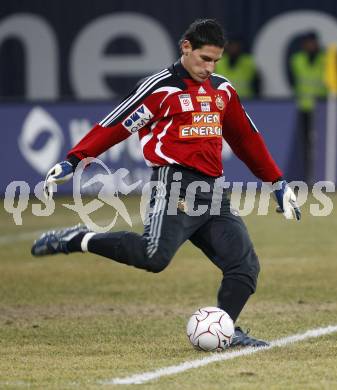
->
xmin=0 ymin=0 xmax=337 ymax=194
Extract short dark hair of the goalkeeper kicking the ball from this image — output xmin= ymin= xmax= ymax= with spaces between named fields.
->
xmin=179 ymin=19 xmax=227 ymax=50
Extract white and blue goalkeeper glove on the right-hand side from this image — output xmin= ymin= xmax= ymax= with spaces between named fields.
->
xmin=273 ymin=180 xmax=301 ymax=221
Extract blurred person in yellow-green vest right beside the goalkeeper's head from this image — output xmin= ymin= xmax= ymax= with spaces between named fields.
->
xmin=215 ymin=37 xmax=261 ymax=99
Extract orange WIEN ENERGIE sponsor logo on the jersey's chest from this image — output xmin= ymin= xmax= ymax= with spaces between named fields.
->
xmin=179 ymin=112 xmax=222 ymax=138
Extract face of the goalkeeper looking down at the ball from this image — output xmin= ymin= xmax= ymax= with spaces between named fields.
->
xmin=181 ymin=40 xmax=223 ymax=83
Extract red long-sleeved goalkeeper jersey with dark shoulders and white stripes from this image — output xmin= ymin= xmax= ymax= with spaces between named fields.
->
xmin=68 ymin=61 xmax=282 ymax=181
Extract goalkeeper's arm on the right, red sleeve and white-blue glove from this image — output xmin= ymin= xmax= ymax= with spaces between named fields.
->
xmin=223 ymin=88 xmax=301 ymax=220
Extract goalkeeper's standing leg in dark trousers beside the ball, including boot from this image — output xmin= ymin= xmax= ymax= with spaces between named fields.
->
xmin=191 ymin=204 xmax=267 ymax=346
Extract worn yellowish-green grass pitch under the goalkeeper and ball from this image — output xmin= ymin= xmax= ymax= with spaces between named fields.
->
xmin=0 ymin=194 xmax=337 ymax=390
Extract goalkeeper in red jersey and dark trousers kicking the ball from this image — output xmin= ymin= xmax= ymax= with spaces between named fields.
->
xmin=32 ymin=19 xmax=301 ymax=346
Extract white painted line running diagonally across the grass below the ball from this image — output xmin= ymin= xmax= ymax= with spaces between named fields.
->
xmin=99 ymin=325 xmax=337 ymax=385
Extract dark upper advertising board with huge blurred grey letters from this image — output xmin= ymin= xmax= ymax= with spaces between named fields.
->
xmin=0 ymin=0 xmax=337 ymax=100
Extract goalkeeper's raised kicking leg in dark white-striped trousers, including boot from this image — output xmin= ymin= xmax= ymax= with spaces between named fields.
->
xmin=32 ymin=167 xmax=203 ymax=272
